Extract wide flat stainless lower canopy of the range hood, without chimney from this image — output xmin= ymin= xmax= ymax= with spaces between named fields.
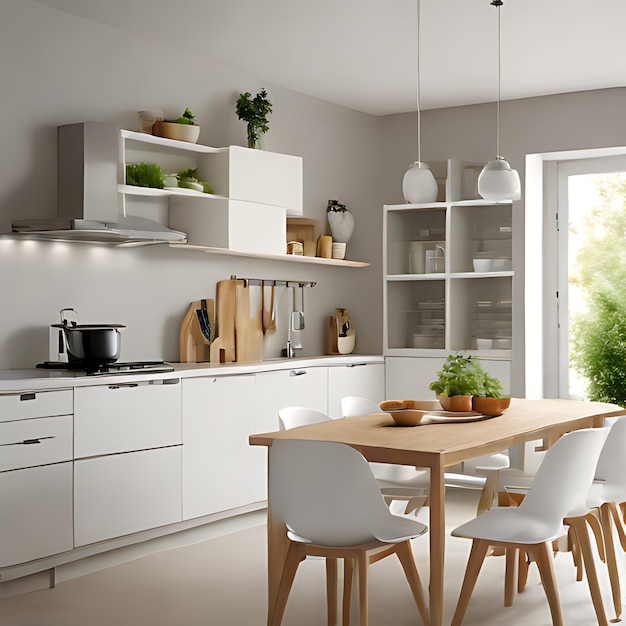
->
xmin=12 ymin=215 xmax=187 ymax=246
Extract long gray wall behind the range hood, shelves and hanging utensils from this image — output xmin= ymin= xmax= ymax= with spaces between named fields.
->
xmin=0 ymin=0 xmax=383 ymax=368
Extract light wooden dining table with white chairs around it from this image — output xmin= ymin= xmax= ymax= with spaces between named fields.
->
xmin=250 ymin=398 xmax=626 ymax=626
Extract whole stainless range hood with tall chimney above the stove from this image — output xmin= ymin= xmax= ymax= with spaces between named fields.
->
xmin=11 ymin=122 xmax=187 ymax=246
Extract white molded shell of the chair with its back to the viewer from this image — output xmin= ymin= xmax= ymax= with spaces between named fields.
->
xmin=269 ymin=439 xmax=425 ymax=546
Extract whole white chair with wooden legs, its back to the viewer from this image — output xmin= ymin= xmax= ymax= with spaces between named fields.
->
xmin=269 ymin=439 xmax=428 ymax=626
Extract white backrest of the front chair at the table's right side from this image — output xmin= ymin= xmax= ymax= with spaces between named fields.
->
xmin=520 ymin=428 xmax=608 ymax=523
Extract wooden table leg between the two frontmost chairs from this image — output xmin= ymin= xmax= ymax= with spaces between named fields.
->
xmin=429 ymin=458 xmax=446 ymax=626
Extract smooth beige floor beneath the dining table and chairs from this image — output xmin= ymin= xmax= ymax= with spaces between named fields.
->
xmin=0 ymin=490 xmax=625 ymax=626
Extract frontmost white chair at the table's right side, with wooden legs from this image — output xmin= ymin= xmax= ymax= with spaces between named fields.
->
xmin=452 ymin=428 xmax=607 ymax=626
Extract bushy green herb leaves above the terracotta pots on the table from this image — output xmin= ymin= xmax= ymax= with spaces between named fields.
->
xmin=428 ymin=354 xmax=502 ymax=398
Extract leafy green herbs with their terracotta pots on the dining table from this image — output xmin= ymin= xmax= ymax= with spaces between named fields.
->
xmin=428 ymin=354 xmax=510 ymax=415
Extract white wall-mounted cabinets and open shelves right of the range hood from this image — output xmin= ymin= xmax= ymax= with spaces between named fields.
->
xmin=117 ymin=130 xmax=369 ymax=267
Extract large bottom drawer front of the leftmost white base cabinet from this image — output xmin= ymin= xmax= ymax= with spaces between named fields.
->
xmin=0 ymin=463 xmax=73 ymax=567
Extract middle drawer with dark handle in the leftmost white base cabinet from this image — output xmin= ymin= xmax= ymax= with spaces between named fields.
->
xmin=0 ymin=415 xmax=72 ymax=471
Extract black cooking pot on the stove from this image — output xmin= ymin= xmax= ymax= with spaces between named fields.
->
xmin=53 ymin=324 xmax=124 ymax=367
